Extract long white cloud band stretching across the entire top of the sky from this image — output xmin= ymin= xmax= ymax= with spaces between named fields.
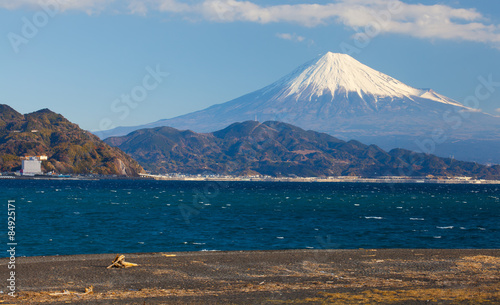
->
xmin=0 ymin=0 xmax=500 ymax=48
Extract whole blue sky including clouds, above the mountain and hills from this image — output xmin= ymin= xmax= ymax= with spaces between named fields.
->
xmin=0 ymin=0 xmax=500 ymax=130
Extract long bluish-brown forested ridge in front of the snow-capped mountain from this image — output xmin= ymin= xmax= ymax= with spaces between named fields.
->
xmin=105 ymin=121 xmax=500 ymax=178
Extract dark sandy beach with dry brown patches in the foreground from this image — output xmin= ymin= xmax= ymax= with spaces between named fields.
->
xmin=0 ymin=249 xmax=500 ymax=304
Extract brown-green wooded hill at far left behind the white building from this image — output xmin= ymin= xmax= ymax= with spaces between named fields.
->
xmin=0 ymin=105 xmax=143 ymax=176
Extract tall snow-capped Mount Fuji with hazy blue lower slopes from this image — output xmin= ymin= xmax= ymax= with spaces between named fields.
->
xmin=97 ymin=52 xmax=500 ymax=164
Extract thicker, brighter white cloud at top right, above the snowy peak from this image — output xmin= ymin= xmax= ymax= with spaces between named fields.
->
xmin=158 ymin=0 xmax=500 ymax=48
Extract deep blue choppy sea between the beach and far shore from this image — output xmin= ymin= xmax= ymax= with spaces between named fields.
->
xmin=0 ymin=180 xmax=500 ymax=256
